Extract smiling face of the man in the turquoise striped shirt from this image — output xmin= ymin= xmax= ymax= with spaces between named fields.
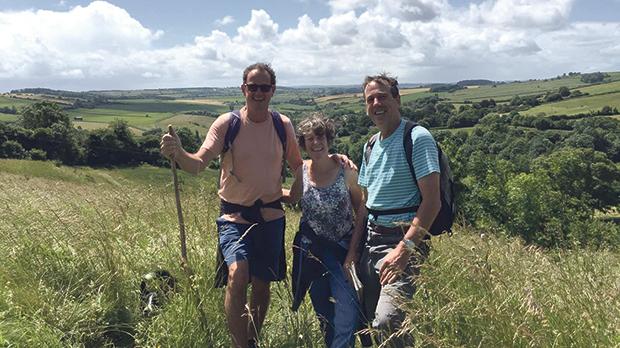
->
xmin=364 ymin=81 xmax=400 ymax=132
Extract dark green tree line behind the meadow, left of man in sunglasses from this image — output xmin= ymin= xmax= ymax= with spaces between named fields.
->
xmin=0 ymin=102 xmax=202 ymax=167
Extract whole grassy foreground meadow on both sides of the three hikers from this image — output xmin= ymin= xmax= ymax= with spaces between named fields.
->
xmin=0 ymin=160 xmax=620 ymax=347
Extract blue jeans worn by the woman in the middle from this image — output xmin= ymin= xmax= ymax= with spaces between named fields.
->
xmin=310 ymin=249 xmax=360 ymax=348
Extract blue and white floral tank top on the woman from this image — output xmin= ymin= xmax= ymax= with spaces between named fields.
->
xmin=301 ymin=163 xmax=353 ymax=242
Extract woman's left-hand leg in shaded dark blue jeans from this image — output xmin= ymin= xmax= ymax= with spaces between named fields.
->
xmin=309 ymin=274 xmax=334 ymax=347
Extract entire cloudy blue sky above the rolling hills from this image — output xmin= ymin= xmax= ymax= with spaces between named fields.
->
xmin=0 ymin=0 xmax=620 ymax=92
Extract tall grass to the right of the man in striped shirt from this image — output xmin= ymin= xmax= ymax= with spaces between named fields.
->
xmin=406 ymin=230 xmax=620 ymax=347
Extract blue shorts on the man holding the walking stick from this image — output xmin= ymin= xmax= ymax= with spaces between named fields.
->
xmin=216 ymin=217 xmax=286 ymax=281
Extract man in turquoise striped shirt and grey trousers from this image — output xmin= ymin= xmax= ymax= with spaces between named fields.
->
xmin=359 ymin=74 xmax=441 ymax=347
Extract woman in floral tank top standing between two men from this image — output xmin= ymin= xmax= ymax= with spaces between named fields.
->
xmin=283 ymin=115 xmax=366 ymax=347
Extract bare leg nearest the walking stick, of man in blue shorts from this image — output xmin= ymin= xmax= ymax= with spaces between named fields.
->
xmin=224 ymin=261 xmax=249 ymax=348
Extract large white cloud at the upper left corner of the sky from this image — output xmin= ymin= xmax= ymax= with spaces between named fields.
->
xmin=0 ymin=1 xmax=163 ymax=85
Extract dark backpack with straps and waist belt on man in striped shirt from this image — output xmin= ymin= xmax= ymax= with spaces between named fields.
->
xmin=364 ymin=121 xmax=456 ymax=236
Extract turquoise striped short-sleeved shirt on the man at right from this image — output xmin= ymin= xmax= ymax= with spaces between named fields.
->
xmin=358 ymin=120 xmax=439 ymax=227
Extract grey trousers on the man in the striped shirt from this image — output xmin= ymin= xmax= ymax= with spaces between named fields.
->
xmin=360 ymin=225 xmax=429 ymax=347
